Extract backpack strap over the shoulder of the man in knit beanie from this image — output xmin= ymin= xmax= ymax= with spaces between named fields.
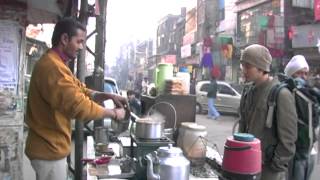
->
xmin=266 ymin=83 xmax=287 ymax=128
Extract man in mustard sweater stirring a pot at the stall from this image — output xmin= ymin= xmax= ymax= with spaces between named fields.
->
xmin=25 ymin=18 xmax=126 ymax=180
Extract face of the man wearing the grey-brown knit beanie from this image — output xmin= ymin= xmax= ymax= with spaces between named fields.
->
xmin=241 ymin=62 xmax=263 ymax=82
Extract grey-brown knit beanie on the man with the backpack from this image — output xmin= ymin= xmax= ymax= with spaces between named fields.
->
xmin=240 ymin=44 xmax=272 ymax=72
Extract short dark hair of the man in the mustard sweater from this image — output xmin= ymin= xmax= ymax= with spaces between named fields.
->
xmin=51 ymin=17 xmax=86 ymax=47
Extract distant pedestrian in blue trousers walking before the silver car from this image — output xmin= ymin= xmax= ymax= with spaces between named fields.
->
xmin=207 ymin=76 xmax=220 ymax=120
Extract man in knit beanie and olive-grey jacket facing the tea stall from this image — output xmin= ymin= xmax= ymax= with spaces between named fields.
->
xmin=239 ymin=44 xmax=298 ymax=180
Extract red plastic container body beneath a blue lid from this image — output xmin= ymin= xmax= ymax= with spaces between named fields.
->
xmin=222 ymin=136 xmax=262 ymax=175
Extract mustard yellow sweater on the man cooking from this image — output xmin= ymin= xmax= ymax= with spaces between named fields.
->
xmin=25 ymin=50 xmax=104 ymax=160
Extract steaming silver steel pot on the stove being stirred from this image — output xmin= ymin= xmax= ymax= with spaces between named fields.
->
xmin=135 ymin=118 xmax=164 ymax=139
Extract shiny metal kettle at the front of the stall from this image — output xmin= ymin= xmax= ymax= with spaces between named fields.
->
xmin=146 ymin=144 xmax=190 ymax=180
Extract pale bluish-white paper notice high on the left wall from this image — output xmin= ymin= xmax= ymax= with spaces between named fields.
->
xmin=0 ymin=23 xmax=20 ymax=93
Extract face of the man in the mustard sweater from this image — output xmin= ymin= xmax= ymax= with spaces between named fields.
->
xmin=64 ymin=29 xmax=86 ymax=59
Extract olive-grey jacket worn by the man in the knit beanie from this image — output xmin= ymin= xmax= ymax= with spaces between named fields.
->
xmin=239 ymin=79 xmax=298 ymax=180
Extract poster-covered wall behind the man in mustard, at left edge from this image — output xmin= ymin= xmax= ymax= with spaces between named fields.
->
xmin=0 ymin=20 xmax=25 ymax=179
